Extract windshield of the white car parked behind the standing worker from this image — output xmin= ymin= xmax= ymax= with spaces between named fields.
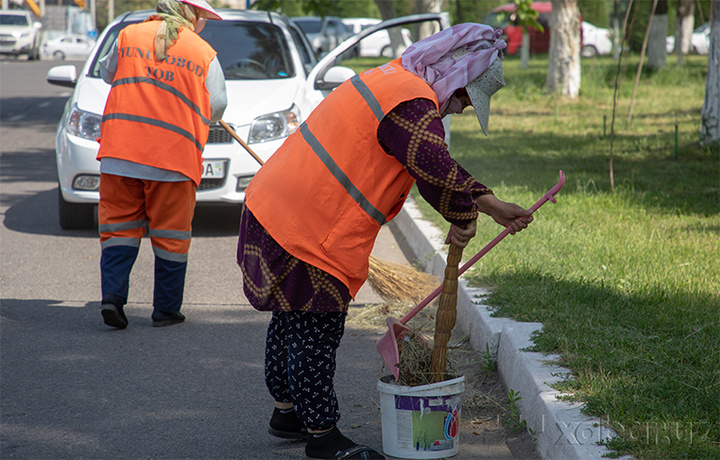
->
xmin=89 ymin=21 xmax=295 ymax=80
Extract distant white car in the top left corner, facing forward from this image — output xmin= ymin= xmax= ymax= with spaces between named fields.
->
xmin=0 ymin=10 xmax=42 ymax=60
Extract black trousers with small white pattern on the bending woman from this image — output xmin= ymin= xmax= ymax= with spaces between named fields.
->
xmin=265 ymin=311 xmax=345 ymax=430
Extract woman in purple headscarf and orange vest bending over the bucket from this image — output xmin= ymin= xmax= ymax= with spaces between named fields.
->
xmin=237 ymin=24 xmax=532 ymax=458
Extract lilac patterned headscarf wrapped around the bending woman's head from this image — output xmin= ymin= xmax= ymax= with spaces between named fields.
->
xmin=402 ymin=23 xmax=507 ymax=113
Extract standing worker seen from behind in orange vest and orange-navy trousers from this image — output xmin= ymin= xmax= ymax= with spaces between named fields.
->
xmin=98 ymin=0 xmax=227 ymax=329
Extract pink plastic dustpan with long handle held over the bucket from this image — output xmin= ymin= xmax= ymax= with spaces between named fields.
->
xmin=376 ymin=171 xmax=565 ymax=380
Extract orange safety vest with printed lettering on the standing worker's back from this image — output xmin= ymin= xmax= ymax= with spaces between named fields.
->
xmin=97 ymin=21 xmax=217 ymax=185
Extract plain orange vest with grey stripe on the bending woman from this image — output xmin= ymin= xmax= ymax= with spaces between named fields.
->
xmin=245 ymin=59 xmax=438 ymax=297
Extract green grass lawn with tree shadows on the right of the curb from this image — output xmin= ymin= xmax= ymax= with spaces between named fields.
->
xmin=345 ymin=56 xmax=720 ymax=459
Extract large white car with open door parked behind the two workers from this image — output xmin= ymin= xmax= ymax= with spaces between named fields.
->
xmin=47 ymin=10 xmax=448 ymax=229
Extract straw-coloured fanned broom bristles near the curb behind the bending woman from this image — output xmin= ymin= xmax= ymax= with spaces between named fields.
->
xmin=368 ymin=256 xmax=438 ymax=303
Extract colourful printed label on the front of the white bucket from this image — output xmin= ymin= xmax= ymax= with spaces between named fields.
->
xmin=395 ymin=395 xmax=462 ymax=452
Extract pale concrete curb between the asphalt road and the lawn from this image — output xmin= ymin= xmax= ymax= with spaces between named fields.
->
xmin=388 ymin=200 xmax=617 ymax=460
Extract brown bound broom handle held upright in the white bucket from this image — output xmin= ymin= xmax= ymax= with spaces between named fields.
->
xmin=430 ymin=244 xmax=463 ymax=383
